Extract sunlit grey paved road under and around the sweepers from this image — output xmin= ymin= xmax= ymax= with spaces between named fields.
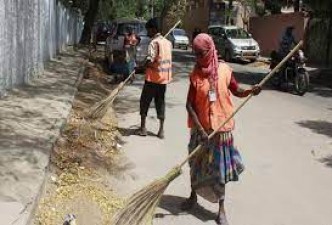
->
xmin=112 ymin=49 xmax=332 ymax=225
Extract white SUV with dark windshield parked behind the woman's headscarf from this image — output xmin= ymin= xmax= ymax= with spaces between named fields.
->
xmin=208 ymin=25 xmax=260 ymax=62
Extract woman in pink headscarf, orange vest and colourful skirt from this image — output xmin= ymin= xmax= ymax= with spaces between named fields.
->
xmin=182 ymin=33 xmax=261 ymax=225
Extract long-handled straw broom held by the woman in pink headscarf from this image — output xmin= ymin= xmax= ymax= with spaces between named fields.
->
xmin=111 ymin=41 xmax=303 ymax=225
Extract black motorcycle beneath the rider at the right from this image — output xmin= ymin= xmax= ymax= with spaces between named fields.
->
xmin=270 ymin=50 xmax=310 ymax=96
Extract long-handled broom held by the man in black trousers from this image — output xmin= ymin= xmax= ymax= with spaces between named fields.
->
xmin=87 ymin=20 xmax=181 ymax=119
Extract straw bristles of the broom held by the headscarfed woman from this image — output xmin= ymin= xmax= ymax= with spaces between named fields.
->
xmin=111 ymin=167 xmax=181 ymax=225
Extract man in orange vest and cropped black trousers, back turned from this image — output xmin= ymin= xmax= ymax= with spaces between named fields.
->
xmin=139 ymin=18 xmax=172 ymax=139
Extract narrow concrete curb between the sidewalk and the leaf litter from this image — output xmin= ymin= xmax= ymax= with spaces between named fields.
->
xmin=26 ymin=56 xmax=88 ymax=225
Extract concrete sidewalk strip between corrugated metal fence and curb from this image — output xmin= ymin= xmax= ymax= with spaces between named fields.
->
xmin=0 ymin=48 xmax=84 ymax=225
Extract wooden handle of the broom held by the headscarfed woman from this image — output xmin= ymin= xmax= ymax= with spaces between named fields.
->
xmin=179 ymin=41 xmax=303 ymax=168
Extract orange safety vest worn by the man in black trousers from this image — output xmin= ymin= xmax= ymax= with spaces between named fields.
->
xmin=145 ymin=37 xmax=172 ymax=84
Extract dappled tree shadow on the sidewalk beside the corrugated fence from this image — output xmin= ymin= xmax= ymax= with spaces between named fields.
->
xmin=0 ymin=52 xmax=85 ymax=158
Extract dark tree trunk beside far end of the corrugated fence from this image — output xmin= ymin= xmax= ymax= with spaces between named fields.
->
xmin=80 ymin=0 xmax=100 ymax=44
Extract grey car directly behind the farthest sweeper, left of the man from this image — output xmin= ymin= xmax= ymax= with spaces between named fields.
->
xmin=105 ymin=19 xmax=150 ymax=67
